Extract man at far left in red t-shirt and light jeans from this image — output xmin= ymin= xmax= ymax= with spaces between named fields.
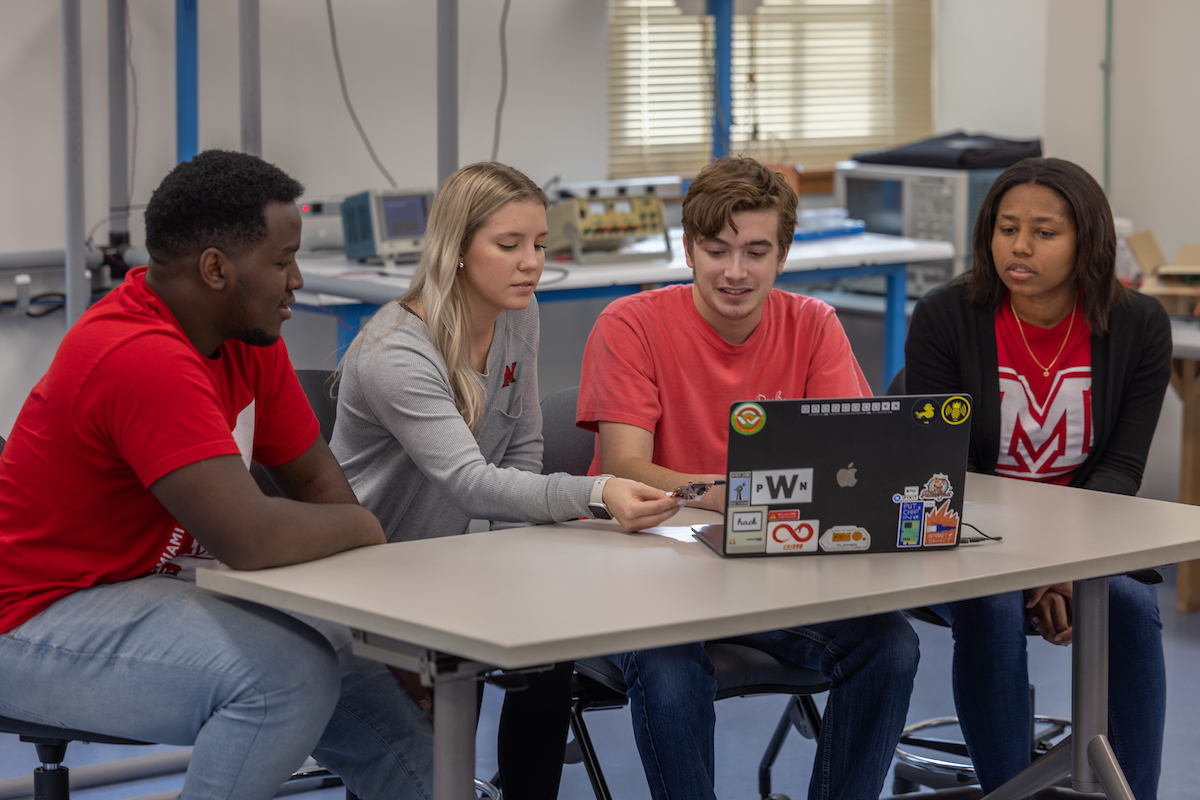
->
xmin=0 ymin=151 xmax=432 ymax=800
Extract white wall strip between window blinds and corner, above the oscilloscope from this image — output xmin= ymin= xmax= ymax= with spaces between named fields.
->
xmin=934 ymin=0 xmax=1057 ymax=139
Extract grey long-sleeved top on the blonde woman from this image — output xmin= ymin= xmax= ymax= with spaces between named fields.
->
xmin=329 ymin=301 xmax=595 ymax=542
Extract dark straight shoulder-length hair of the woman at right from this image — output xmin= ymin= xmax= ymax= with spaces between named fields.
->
xmin=961 ymin=158 xmax=1129 ymax=333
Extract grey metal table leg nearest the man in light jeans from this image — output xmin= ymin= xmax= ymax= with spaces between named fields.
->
xmin=433 ymin=675 xmax=479 ymax=800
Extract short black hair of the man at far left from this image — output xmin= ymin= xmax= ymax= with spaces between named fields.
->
xmin=145 ymin=150 xmax=304 ymax=265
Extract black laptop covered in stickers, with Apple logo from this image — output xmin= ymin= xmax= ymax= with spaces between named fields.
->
xmin=692 ymin=395 xmax=972 ymax=557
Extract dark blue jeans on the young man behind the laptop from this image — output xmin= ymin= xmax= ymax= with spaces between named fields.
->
xmin=608 ymin=614 xmax=919 ymax=800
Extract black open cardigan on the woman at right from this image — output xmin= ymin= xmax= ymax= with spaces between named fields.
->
xmin=905 ymin=279 xmax=1171 ymax=494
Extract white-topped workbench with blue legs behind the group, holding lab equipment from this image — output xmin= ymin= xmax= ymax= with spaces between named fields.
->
xmin=288 ymin=228 xmax=954 ymax=386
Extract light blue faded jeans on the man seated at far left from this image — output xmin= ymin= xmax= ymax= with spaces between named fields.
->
xmin=0 ymin=576 xmax=433 ymax=800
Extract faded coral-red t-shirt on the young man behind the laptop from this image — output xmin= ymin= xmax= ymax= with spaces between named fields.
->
xmin=576 ymin=283 xmax=871 ymax=475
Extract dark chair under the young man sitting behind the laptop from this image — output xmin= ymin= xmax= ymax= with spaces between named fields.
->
xmin=541 ymin=386 xmax=829 ymax=800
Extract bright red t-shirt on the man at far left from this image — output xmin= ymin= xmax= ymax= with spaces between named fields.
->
xmin=0 ymin=267 xmax=320 ymax=632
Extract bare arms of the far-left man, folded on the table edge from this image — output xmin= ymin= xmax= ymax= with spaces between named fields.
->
xmin=150 ymin=450 xmax=385 ymax=570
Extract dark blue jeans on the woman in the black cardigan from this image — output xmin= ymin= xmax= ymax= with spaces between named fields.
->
xmin=932 ymin=576 xmax=1166 ymax=800
